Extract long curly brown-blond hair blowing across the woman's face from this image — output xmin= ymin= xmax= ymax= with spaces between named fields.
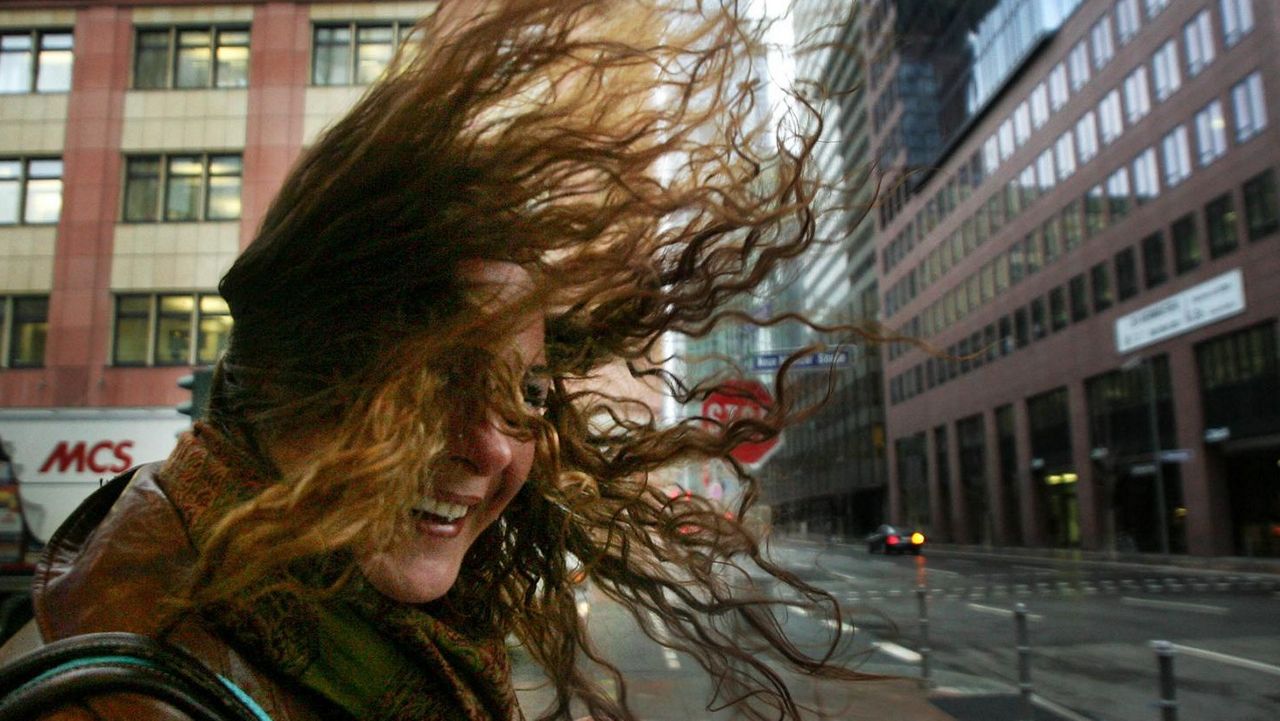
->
xmin=191 ymin=0 xmax=880 ymax=718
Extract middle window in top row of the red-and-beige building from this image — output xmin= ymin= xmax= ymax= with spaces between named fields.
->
xmin=133 ymin=27 xmax=248 ymax=90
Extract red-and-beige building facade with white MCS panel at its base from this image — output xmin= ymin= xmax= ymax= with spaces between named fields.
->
xmin=0 ymin=0 xmax=434 ymax=525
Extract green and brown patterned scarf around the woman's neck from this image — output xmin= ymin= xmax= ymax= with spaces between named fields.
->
xmin=161 ymin=424 xmax=524 ymax=721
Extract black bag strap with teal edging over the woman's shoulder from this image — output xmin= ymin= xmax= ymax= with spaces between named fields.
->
xmin=0 ymin=631 xmax=271 ymax=721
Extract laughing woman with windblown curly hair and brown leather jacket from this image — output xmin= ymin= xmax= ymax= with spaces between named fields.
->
xmin=2 ymin=0 xmax=858 ymax=720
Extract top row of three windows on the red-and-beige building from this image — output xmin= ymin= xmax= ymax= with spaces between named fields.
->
xmin=0 ymin=20 xmax=413 ymax=93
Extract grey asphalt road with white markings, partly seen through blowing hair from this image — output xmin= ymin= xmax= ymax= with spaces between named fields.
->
xmin=517 ymin=542 xmax=1280 ymax=721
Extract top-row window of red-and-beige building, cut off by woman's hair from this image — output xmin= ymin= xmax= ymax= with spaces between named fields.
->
xmin=311 ymin=20 xmax=413 ymax=85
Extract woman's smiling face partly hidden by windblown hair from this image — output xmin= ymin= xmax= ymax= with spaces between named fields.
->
xmin=360 ymin=261 xmax=547 ymax=603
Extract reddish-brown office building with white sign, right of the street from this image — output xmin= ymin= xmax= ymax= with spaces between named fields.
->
xmin=870 ymin=0 xmax=1280 ymax=556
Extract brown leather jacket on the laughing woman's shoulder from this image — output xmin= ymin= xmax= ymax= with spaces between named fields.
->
xmin=0 ymin=464 xmax=332 ymax=721
